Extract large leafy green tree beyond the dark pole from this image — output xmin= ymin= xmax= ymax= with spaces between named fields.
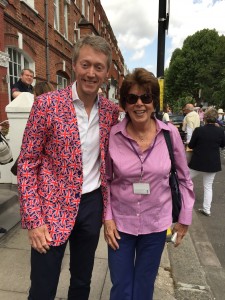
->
xmin=164 ymin=29 xmax=225 ymax=111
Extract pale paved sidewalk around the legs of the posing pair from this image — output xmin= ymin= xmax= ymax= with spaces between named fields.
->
xmin=0 ymin=224 xmax=175 ymax=300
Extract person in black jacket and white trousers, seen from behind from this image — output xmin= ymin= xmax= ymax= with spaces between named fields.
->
xmin=188 ymin=108 xmax=225 ymax=217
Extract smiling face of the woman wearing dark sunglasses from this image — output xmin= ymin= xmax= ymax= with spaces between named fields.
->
xmin=125 ymin=84 xmax=155 ymax=123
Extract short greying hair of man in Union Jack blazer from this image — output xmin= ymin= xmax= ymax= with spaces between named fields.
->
xmin=73 ymin=35 xmax=112 ymax=70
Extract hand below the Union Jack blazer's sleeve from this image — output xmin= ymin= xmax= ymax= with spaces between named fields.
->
xmin=28 ymin=225 xmax=52 ymax=253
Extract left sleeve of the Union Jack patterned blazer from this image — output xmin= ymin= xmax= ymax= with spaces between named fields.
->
xmin=17 ymin=97 xmax=50 ymax=229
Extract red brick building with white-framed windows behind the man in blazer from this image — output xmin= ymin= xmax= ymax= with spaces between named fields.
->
xmin=0 ymin=0 xmax=124 ymax=121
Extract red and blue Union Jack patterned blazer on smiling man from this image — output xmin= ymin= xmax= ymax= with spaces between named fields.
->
xmin=18 ymin=86 xmax=118 ymax=246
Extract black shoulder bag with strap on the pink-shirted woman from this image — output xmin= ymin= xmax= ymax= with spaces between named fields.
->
xmin=163 ymin=130 xmax=181 ymax=223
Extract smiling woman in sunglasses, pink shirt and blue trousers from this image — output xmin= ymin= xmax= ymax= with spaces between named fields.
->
xmin=104 ymin=68 xmax=194 ymax=300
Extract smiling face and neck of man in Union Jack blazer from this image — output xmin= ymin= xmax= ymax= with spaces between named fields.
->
xmin=73 ymin=45 xmax=108 ymax=101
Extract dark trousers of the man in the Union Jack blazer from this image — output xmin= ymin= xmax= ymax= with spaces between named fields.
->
xmin=28 ymin=188 xmax=103 ymax=300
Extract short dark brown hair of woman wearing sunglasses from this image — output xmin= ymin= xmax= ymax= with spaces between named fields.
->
xmin=120 ymin=68 xmax=159 ymax=110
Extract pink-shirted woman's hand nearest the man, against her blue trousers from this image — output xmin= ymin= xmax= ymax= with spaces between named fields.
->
xmin=104 ymin=220 xmax=120 ymax=250
